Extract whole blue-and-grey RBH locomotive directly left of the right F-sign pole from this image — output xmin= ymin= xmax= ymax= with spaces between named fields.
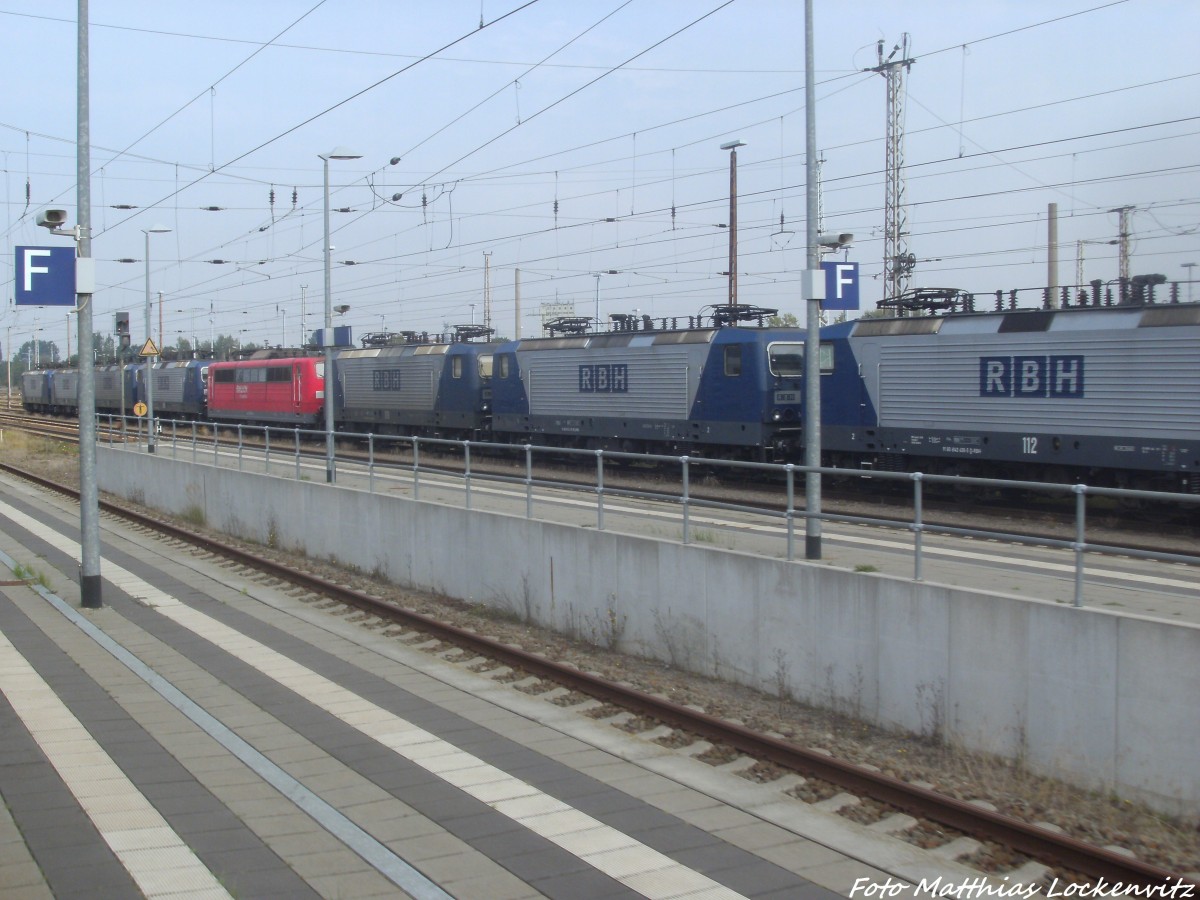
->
xmin=492 ymin=312 xmax=804 ymax=461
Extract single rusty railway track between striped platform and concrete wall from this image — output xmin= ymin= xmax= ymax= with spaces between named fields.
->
xmin=2 ymin=453 xmax=1200 ymax=887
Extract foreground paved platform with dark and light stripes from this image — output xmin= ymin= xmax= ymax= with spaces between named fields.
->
xmin=0 ymin=478 xmax=970 ymax=900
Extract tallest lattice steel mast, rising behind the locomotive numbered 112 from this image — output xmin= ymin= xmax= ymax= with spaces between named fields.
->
xmin=868 ymin=34 xmax=917 ymax=309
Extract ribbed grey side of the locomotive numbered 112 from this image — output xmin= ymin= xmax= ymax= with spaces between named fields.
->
xmin=841 ymin=307 xmax=1200 ymax=484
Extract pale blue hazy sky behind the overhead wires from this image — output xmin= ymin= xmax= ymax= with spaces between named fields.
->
xmin=0 ymin=0 xmax=1200 ymax=352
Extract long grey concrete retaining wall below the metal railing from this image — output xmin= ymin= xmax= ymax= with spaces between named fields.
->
xmin=97 ymin=448 xmax=1200 ymax=818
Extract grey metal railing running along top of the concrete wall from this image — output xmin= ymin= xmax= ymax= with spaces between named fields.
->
xmin=101 ymin=416 xmax=1200 ymax=607
